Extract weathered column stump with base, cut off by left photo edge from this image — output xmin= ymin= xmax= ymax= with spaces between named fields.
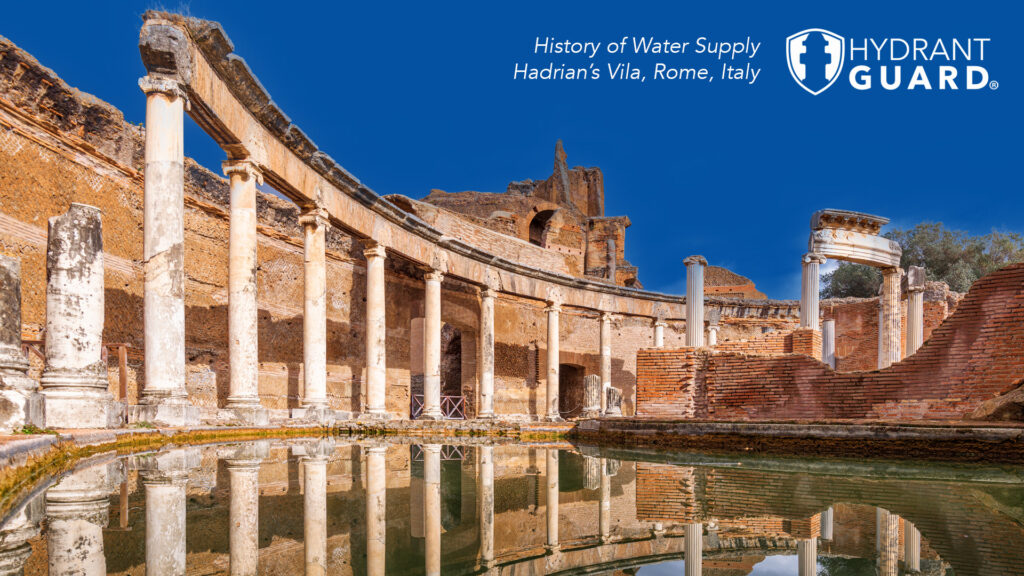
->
xmin=0 ymin=255 xmax=45 ymax=431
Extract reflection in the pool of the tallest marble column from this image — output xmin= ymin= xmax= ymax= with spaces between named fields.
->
xmin=137 ymin=448 xmax=201 ymax=576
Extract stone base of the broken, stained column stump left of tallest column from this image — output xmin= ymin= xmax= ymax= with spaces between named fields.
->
xmin=39 ymin=386 xmax=125 ymax=428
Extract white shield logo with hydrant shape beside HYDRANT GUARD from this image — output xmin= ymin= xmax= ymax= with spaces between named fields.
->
xmin=785 ymin=28 xmax=846 ymax=96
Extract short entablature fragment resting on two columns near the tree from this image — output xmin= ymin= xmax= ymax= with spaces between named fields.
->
xmin=807 ymin=209 xmax=903 ymax=268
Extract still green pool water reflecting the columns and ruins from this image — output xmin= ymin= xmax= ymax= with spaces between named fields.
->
xmin=0 ymin=439 xmax=1024 ymax=576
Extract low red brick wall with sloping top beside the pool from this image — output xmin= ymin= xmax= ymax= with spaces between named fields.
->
xmin=637 ymin=263 xmax=1024 ymax=420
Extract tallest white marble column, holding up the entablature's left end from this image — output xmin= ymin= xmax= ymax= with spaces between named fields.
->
xmin=128 ymin=76 xmax=199 ymax=426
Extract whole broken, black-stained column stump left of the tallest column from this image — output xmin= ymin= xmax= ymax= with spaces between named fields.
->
xmin=40 ymin=204 xmax=123 ymax=428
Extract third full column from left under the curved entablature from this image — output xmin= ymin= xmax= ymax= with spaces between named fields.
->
xmin=299 ymin=208 xmax=329 ymax=420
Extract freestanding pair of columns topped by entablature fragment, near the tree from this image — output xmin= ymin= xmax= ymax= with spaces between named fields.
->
xmin=800 ymin=209 xmax=903 ymax=368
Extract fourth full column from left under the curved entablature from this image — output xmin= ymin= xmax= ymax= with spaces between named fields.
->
xmin=362 ymin=244 xmax=387 ymax=419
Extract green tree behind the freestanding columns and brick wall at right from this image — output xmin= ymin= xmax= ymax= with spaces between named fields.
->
xmin=821 ymin=222 xmax=1024 ymax=298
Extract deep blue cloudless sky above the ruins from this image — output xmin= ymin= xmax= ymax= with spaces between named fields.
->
xmin=6 ymin=0 xmax=1024 ymax=298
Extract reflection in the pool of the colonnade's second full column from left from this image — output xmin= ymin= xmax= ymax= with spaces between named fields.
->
xmin=227 ymin=442 xmax=269 ymax=576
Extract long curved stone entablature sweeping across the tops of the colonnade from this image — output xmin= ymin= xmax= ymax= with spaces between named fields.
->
xmin=132 ymin=11 xmax=795 ymax=319
